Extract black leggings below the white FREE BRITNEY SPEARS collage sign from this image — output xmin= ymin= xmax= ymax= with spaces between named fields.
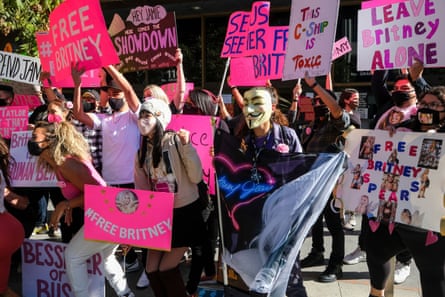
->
xmin=365 ymin=222 xmax=445 ymax=297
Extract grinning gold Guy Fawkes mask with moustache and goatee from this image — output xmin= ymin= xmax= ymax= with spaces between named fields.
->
xmin=243 ymin=88 xmax=272 ymax=129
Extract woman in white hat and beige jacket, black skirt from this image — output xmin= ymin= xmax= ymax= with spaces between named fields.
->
xmin=134 ymin=98 xmax=204 ymax=297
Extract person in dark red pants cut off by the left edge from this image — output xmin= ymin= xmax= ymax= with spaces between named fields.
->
xmin=0 ymin=137 xmax=25 ymax=297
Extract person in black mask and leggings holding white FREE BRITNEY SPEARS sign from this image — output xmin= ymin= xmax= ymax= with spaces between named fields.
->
xmin=365 ymin=86 xmax=445 ymax=297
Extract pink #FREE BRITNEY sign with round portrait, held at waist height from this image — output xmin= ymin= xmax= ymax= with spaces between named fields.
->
xmin=85 ymin=185 xmax=174 ymax=251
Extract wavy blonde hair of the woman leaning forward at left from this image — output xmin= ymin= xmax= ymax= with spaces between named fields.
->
xmin=34 ymin=121 xmax=91 ymax=168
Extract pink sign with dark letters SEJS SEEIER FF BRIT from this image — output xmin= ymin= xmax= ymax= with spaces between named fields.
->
xmin=221 ymin=1 xmax=289 ymax=80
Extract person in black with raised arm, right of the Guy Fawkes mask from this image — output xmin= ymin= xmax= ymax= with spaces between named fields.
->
xmin=301 ymin=76 xmax=350 ymax=283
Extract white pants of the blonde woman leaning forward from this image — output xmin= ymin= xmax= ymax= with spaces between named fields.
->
xmin=65 ymin=226 xmax=131 ymax=297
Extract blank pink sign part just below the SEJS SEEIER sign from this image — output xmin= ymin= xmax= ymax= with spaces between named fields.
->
xmin=230 ymin=57 xmax=266 ymax=87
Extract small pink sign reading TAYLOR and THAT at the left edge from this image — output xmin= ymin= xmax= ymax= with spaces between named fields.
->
xmin=0 ymin=106 xmax=28 ymax=139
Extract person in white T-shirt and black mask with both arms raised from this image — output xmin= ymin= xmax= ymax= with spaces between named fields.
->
xmin=71 ymin=64 xmax=140 ymax=272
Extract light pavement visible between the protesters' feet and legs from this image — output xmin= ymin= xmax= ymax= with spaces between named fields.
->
xmin=10 ymin=217 xmax=421 ymax=297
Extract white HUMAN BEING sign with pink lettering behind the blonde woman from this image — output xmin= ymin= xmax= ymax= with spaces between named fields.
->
xmin=10 ymin=131 xmax=57 ymax=187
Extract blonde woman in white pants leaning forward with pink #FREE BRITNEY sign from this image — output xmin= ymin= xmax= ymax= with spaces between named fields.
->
xmin=28 ymin=119 xmax=134 ymax=297
